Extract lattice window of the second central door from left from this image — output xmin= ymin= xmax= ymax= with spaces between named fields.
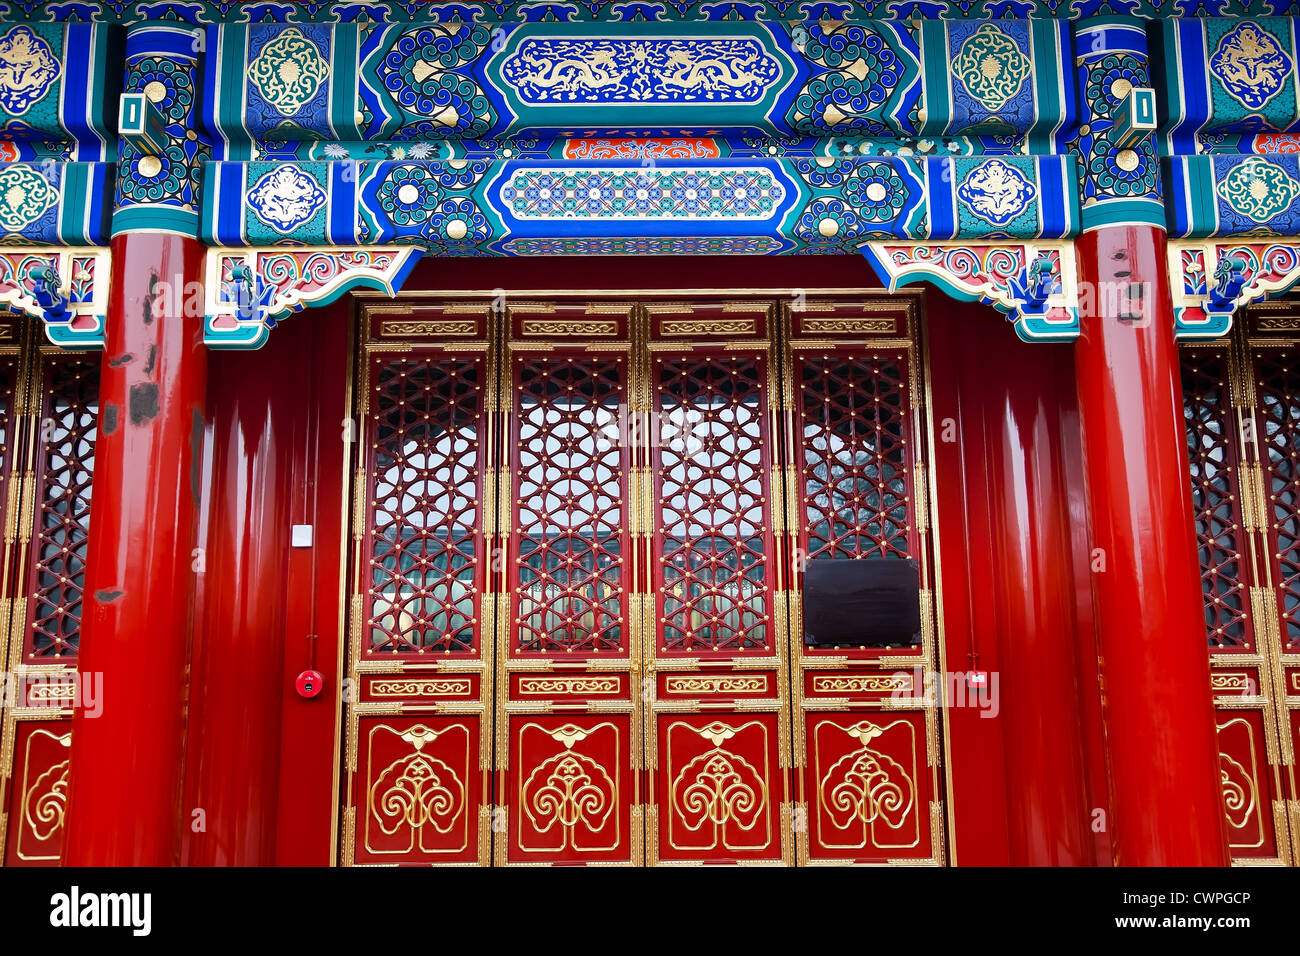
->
xmin=514 ymin=355 xmax=629 ymax=652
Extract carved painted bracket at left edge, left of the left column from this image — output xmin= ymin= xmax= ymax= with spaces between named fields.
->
xmin=0 ymin=247 xmax=112 ymax=349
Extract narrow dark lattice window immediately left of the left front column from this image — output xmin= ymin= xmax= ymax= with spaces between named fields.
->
xmin=27 ymin=355 xmax=99 ymax=659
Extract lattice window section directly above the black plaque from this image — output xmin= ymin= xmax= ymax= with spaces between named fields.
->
xmin=800 ymin=355 xmax=913 ymax=561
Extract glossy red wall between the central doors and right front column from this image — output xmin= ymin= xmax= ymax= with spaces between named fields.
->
xmin=928 ymin=303 xmax=1106 ymax=865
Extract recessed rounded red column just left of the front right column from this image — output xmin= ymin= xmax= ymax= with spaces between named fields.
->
xmin=972 ymin=315 xmax=1096 ymax=866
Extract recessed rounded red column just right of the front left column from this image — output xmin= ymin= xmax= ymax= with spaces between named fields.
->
xmin=185 ymin=323 xmax=299 ymax=865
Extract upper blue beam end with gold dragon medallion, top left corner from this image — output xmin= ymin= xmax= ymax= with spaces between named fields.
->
xmin=0 ymin=23 xmax=122 ymax=161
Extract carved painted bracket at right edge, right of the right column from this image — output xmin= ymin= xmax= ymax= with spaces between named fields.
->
xmin=1169 ymin=239 xmax=1300 ymax=338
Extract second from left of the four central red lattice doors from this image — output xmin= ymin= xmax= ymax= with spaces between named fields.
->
xmin=495 ymin=300 xmax=644 ymax=865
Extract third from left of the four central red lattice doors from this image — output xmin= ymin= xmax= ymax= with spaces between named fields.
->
xmin=642 ymin=300 xmax=794 ymax=865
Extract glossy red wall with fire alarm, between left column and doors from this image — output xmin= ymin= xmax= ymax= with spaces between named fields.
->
xmin=182 ymin=303 xmax=351 ymax=865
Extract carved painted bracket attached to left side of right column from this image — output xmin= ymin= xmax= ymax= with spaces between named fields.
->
xmin=861 ymin=241 xmax=1079 ymax=342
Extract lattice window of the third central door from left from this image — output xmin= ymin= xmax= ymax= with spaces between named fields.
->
xmin=653 ymin=354 xmax=770 ymax=652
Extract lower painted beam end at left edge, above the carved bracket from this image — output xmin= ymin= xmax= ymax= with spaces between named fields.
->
xmin=0 ymin=163 xmax=113 ymax=246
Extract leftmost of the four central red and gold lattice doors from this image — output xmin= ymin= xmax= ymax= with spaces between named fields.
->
xmin=343 ymin=303 xmax=497 ymax=865
